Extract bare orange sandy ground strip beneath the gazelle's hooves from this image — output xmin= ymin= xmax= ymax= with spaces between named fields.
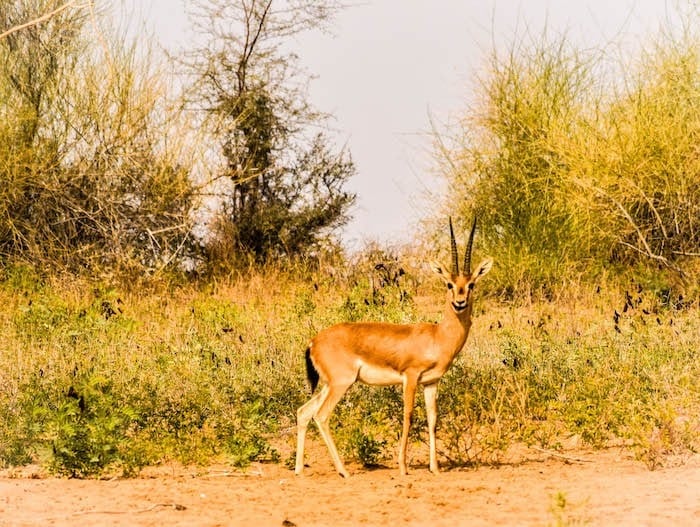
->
xmin=0 ymin=445 xmax=700 ymax=527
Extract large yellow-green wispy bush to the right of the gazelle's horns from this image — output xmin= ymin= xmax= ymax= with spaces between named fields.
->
xmin=442 ymin=16 xmax=700 ymax=295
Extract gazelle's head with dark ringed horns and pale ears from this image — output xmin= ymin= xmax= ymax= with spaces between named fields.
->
xmin=431 ymin=218 xmax=493 ymax=315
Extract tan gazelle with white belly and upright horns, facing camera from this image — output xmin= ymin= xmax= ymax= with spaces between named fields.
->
xmin=295 ymin=218 xmax=493 ymax=477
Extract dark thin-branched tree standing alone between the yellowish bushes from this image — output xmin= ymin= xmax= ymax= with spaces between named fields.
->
xmin=186 ymin=0 xmax=354 ymax=266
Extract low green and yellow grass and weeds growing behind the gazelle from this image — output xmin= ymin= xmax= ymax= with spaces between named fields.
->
xmin=0 ymin=260 xmax=700 ymax=477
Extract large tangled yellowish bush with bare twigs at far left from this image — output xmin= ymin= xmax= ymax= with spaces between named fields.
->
xmin=0 ymin=0 xmax=195 ymax=276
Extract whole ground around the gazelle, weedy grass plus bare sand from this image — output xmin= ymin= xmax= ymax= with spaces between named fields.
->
xmin=0 ymin=266 xmax=700 ymax=525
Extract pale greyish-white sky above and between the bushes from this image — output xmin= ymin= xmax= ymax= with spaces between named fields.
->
xmin=122 ymin=0 xmax=680 ymax=247
